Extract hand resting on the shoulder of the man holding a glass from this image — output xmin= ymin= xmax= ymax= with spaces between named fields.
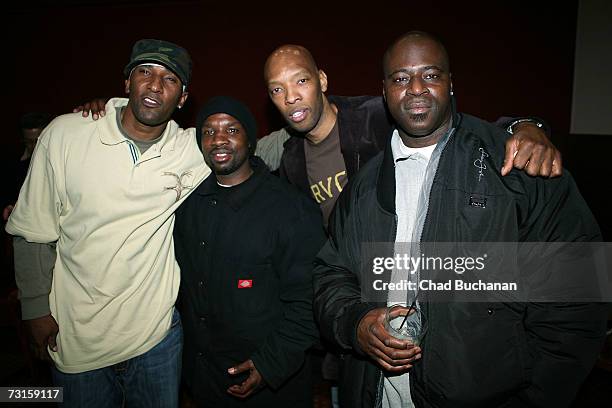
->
xmin=501 ymin=122 xmax=563 ymax=177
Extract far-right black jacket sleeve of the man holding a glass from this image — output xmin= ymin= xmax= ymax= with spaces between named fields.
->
xmin=508 ymin=171 xmax=609 ymax=407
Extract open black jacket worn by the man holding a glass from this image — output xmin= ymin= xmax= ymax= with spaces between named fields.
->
xmin=314 ymin=115 xmax=606 ymax=408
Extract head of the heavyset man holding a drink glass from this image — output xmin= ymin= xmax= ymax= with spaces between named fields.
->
xmin=383 ymin=34 xmax=452 ymax=145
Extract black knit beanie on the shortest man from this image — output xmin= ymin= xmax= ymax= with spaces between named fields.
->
xmin=196 ymin=96 xmax=257 ymax=155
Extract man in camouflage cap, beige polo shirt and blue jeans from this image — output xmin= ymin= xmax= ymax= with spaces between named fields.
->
xmin=6 ymin=39 xmax=210 ymax=407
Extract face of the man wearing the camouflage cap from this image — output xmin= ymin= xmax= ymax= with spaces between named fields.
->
xmin=124 ymin=64 xmax=187 ymax=128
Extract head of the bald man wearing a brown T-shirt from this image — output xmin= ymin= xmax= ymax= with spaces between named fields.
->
xmin=264 ymin=45 xmax=336 ymax=136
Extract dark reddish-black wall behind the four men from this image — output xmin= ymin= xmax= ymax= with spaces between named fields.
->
xmin=0 ymin=0 xmax=612 ymax=240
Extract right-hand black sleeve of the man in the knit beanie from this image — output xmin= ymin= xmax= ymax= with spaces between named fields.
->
xmin=251 ymin=197 xmax=325 ymax=389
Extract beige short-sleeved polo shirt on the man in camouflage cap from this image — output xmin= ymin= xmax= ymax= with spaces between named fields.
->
xmin=6 ymin=99 xmax=210 ymax=373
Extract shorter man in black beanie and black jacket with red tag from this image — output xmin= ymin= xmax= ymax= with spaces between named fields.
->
xmin=174 ymin=97 xmax=324 ymax=407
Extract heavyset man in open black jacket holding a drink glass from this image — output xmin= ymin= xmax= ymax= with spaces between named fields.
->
xmin=314 ymin=32 xmax=606 ymax=407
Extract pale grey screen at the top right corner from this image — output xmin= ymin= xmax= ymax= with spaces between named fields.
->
xmin=570 ymin=0 xmax=612 ymax=136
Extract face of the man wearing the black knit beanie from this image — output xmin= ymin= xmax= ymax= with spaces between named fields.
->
xmin=201 ymin=113 xmax=251 ymax=185
